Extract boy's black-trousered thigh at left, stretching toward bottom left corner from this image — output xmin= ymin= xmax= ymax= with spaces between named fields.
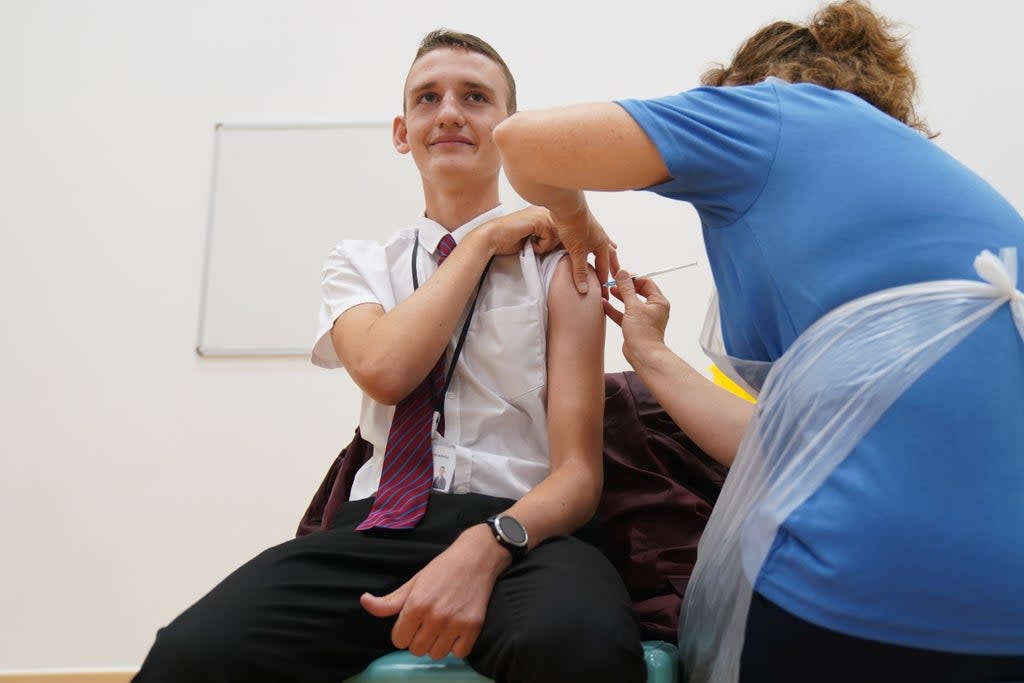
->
xmin=143 ymin=518 xmax=444 ymax=680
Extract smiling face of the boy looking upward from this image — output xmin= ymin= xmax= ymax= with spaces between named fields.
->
xmin=392 ymin=47 xmax=509 ymax=184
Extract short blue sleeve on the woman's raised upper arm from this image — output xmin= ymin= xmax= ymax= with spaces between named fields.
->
xmin=616 ymin=82 xmax=780 ymax=227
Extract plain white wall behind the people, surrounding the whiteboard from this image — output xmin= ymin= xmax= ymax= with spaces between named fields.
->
xmin=0 ymin=0 xmax=1024 ymax=670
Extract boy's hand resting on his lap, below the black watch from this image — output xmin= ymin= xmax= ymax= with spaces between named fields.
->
xmin=359 ymin=524 xmax=512 ymax=659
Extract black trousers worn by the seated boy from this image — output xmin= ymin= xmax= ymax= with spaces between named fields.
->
xmin=134 ymin=494 xmax=646 ymax=683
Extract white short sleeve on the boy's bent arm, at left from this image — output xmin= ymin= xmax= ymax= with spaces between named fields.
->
xmin=310 ymin=241 xmax=394 ymax=368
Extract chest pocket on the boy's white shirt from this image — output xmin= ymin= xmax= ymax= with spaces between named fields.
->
xmin=465 ymin=303 xmax=547 ymax=402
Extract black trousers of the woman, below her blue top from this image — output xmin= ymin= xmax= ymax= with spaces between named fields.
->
xmin=739 ymin=593 xmax=1024 ymax=683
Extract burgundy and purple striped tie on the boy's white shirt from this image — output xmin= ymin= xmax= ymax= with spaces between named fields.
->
xmin=355 ymin=234 xmax=455 ymax=530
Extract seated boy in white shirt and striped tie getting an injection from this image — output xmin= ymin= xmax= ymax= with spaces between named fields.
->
xmin=135 ymin=30 xmax=645 ymax=683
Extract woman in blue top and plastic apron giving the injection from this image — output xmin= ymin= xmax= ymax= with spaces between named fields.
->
xmin=495 ymin=0 xmax=1024 ymax=681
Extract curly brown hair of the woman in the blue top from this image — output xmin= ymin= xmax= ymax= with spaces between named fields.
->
xmin=700 ymin=0 xmax=934 ymax=137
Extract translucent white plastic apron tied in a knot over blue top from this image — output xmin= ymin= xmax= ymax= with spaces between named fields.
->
xmin=680 ymin=248 xmax=1024 ymax=683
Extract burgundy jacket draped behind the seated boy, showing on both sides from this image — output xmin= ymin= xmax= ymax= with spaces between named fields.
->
xmin=296 ymin=371 xmax=727 ymax=642
